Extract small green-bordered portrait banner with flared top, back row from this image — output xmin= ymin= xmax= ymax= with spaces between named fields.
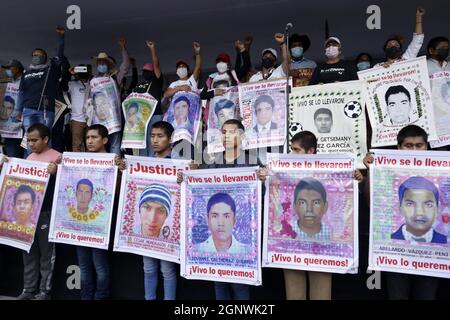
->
xmin=122 ymin=93 xmax=158 ymax=149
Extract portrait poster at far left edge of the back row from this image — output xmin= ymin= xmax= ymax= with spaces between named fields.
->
xmin=0 ymin=82 xmax=23 ymax=139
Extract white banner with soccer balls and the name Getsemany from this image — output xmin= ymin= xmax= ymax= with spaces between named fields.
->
xmin=288 ymin=81 xmax=367 ymax=169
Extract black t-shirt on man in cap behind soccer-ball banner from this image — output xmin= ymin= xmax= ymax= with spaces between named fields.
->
xmin=310 ymin=60 xmax=358 ymax=84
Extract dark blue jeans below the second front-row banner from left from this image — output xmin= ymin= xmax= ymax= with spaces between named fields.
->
xmin=77 ymin=247 xmax=110 ymax=300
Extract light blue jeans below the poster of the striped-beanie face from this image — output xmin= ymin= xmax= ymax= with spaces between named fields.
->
xmin=143 ymin=257 xmax=177 ymax=300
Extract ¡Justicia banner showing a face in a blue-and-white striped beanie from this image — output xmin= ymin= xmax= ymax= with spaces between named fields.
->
xmin=114 ymin=155 xmax=190 ymax=263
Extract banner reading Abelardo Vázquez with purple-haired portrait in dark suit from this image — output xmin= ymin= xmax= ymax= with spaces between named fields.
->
xmin=369 ymin=149 xmax=450 ymax=278
